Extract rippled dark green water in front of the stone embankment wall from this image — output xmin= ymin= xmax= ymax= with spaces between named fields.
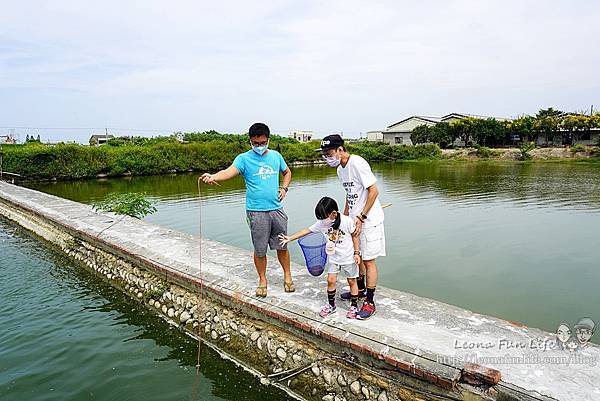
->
xmin=0 ymin=220 xmax=296 ymax=401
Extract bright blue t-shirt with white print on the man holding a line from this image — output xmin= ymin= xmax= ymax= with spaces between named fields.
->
xmin=233 ymin=149 xmax=287 ymax=212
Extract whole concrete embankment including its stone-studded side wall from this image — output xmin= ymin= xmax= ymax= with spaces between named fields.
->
xmin=0 ymin=182 xmax=600 ymax=401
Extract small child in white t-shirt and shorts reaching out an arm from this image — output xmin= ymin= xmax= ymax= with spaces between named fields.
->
xmin=279 ymin=197 xmax=360 ymax=319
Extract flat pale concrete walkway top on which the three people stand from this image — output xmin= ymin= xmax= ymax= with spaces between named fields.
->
xmin=0 ymin=182 xmax=600 ymax=401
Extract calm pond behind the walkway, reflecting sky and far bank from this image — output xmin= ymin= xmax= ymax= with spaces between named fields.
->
xmin=25 ymin=162 xmax=600 ymax=331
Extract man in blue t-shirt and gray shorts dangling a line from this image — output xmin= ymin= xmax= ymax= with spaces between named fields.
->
xmin=200 ymin=123 xmax=295 ymax=297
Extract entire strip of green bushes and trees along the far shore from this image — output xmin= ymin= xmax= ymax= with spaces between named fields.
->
xmin=0 ymin=109 xmax=600 ymax=180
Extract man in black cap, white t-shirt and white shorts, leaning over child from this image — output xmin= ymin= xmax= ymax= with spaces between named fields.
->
xmin=317 ymin=135 xmax=385 ymax=320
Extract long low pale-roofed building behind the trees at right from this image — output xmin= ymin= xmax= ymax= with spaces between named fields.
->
xmin=382 ymin=113 xmax=507 ymax=146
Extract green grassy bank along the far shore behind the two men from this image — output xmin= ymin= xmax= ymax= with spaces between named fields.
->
xmin=2 ymin=133 xmax=441 ymax=179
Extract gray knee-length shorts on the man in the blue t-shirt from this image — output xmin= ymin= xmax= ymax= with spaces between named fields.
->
xmin=246 ymin=209 xmax=287 ymax=257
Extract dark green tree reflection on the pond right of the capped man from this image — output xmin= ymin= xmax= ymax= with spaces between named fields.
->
xmin=377 ymin=162 xmax=600 ymax=210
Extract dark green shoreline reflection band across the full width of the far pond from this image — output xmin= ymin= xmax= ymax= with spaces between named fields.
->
xmin=28 ymin=162 xmax=600 ymax=210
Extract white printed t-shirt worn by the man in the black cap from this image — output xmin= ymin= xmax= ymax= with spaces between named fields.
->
xmin=337 ymin=155 xmax=384 ymax=227
